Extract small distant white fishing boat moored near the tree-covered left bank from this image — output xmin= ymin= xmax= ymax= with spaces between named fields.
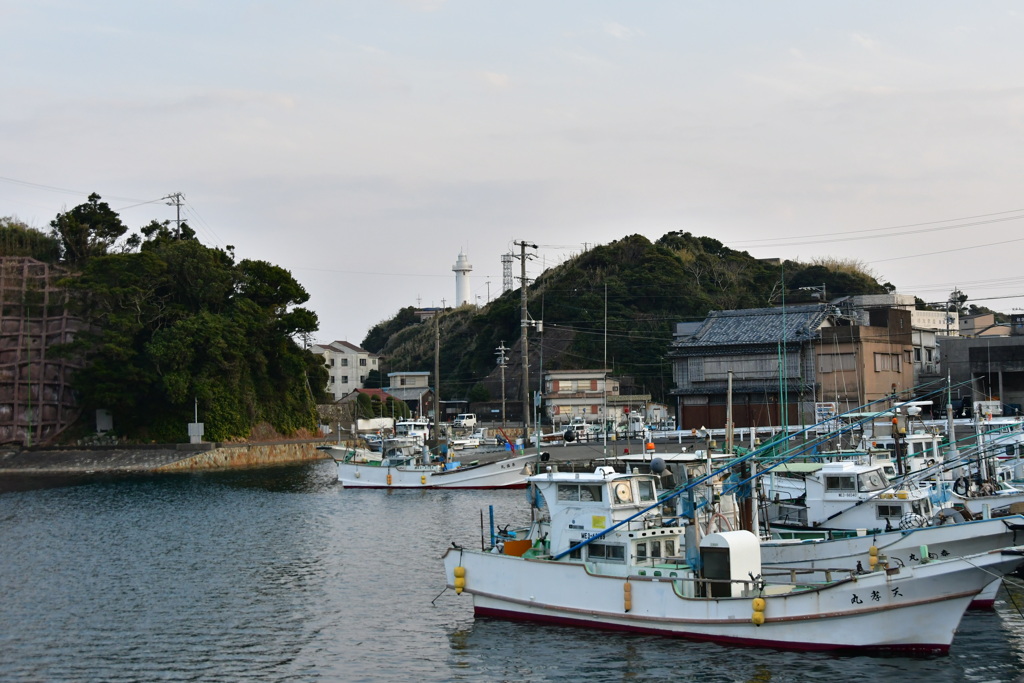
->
xmin=319 ymin=445 xmax=538 ymax=488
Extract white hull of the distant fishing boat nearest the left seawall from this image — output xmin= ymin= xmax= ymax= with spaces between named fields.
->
xmin=336 ymin=455 xmax=537 ymax=488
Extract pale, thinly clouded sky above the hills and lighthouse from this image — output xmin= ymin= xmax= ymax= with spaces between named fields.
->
xmin=0 ymin=0 xmax=1024 ymax=344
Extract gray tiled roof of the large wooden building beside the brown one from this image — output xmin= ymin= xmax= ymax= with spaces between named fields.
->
xmin=673 ymin=304 xmax=828 ymax=349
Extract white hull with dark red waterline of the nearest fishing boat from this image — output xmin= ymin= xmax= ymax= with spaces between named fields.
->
xmin=444 ymin=549 xmax=1021 ymax=651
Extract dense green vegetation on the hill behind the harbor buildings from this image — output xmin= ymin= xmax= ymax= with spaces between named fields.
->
xmin=362 ymin=232 xmax=891 ymax=409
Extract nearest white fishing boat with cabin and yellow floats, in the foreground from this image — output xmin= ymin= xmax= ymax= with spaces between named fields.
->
xmin=443 ymin=467 xmax=1024 ymax=651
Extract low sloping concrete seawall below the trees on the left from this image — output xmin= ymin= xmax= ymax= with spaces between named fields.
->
xmin=0 ymin=440 xmax=342 ymax=476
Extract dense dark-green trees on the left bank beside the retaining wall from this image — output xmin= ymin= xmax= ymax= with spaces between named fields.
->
xmin=0 ymin=195 xmax=327 ymax=441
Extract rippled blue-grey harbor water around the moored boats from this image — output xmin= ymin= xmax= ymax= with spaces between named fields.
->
xmin=6 ymin=462 xmax=1024 ymax=683
